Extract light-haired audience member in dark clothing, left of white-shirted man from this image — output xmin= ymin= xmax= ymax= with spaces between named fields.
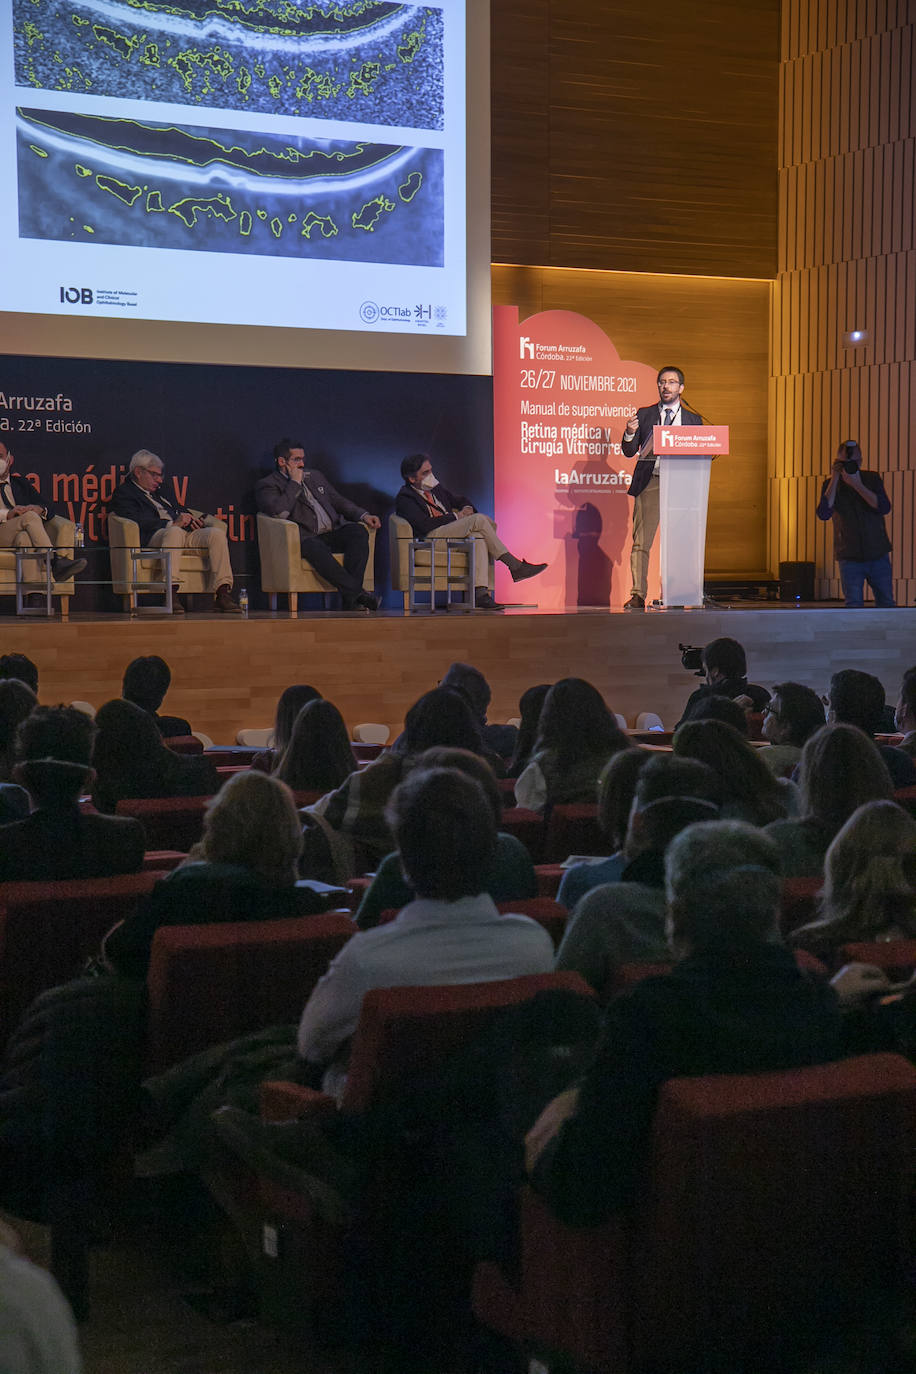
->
xmin=103 ymin=771 xmax=328 ymax=978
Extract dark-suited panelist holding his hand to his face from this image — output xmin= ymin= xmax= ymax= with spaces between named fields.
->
xmin=254 ymin=438 xmax=380 ymax=611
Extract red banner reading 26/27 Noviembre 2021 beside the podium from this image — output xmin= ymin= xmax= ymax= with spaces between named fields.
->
xmin=493 ymin=305 xmax=667 ymax=610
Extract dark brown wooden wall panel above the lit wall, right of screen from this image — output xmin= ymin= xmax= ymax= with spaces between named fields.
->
xmin=490 ymin=0 xmax=780 ymax=278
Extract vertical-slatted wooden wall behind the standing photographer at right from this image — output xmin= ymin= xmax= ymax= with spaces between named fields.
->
xmin=769 ymin=0 xmax=916 ymax=603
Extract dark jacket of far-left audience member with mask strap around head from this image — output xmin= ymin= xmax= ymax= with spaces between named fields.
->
xmin=0 ymin=807 xmax=146 ymax=882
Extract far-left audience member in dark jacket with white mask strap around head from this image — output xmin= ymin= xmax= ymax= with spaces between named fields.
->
xmin=0 ymin=706 xmax=144 ymax=882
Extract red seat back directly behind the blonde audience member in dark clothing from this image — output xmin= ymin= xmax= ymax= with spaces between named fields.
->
xmin=147 ymin=911 xmax=356 ymax=1072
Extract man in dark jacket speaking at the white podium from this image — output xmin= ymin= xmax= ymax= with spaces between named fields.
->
xmin=621 ymin=367 xmax=703 ymax=610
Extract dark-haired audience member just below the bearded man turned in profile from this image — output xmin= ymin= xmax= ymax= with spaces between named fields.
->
xmin=673 ymin=720 xmax=798 ymax=826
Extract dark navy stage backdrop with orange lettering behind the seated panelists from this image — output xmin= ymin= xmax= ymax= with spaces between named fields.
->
xmin=0 ymin=357 xmax=493 ymax=610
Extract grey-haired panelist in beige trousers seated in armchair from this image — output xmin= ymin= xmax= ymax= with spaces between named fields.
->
xmin=108 ymin=448 xmax=239 ymax=616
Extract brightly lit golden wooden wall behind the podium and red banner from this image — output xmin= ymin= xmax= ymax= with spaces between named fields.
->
xmin=493 ymin=267 xmax=772 ymax=576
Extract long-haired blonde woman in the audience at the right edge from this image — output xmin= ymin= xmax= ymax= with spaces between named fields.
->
xmin=792 ymin=801 xmax=916 ymax=960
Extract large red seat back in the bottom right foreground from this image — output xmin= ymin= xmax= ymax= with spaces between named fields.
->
xmin=632 ymin=1054 xmax=916 ymax=1363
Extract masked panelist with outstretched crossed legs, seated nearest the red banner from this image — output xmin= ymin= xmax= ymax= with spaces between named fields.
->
xmin=394 ymin=453 xmax=547 ymax=610
